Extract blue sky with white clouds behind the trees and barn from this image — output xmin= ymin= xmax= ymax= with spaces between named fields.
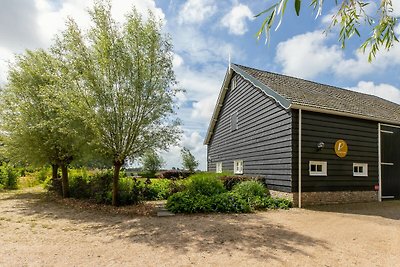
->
xmin=0 ymin=0 xmax=400 ymax=169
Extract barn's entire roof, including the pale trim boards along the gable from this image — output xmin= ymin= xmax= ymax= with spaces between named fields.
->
xmin=204 ymin=64 xmax=400 ymax=144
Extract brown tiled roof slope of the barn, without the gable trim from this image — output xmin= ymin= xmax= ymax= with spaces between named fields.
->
xmin=236 ymin=65 xmax=400 ymax=123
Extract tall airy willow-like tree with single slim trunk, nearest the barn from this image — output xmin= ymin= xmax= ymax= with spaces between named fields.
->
xmin=57 ymin=2 xmax=179 ymax=205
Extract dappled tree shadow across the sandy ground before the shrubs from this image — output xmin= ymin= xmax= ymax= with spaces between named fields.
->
xmin=2 ymin=189 xmax=329 ymax=261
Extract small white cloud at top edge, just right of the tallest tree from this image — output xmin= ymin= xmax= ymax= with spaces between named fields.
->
xmin=178 ymin=0 xmax=217 ymax=24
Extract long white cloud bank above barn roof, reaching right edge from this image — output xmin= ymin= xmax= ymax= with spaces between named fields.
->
xmin=275 ymin=31 xmax=400 ymax=79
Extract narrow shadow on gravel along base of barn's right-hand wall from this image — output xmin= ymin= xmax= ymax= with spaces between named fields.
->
xmin=307 ymin=200 xmax=400 ymax=220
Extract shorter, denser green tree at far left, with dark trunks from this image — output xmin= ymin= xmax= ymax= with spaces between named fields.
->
xmin=1 ymin=50 xmax=88 ymax=197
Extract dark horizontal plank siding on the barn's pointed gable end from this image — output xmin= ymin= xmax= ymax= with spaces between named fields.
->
xmin=207 ymin=75 xmax=292 ymax=192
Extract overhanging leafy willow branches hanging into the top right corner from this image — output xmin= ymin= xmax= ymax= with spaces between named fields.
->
xmin=256 ymin=0 xmax=399 ymax=61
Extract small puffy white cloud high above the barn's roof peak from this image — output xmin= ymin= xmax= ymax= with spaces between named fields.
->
xmin=221 ymin=4 xmax=254 ymax=35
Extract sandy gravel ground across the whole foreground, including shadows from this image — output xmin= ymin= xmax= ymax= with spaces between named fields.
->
xmin=0 ymin=188 xmax=400 ymax=266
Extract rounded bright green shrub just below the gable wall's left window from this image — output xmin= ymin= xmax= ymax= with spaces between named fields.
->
xmin=186 ymin=173 xmax=226 ymax=196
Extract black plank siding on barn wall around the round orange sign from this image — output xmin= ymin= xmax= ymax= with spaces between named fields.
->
xmin=292 ymin=110 xmax=378 ymax=192
